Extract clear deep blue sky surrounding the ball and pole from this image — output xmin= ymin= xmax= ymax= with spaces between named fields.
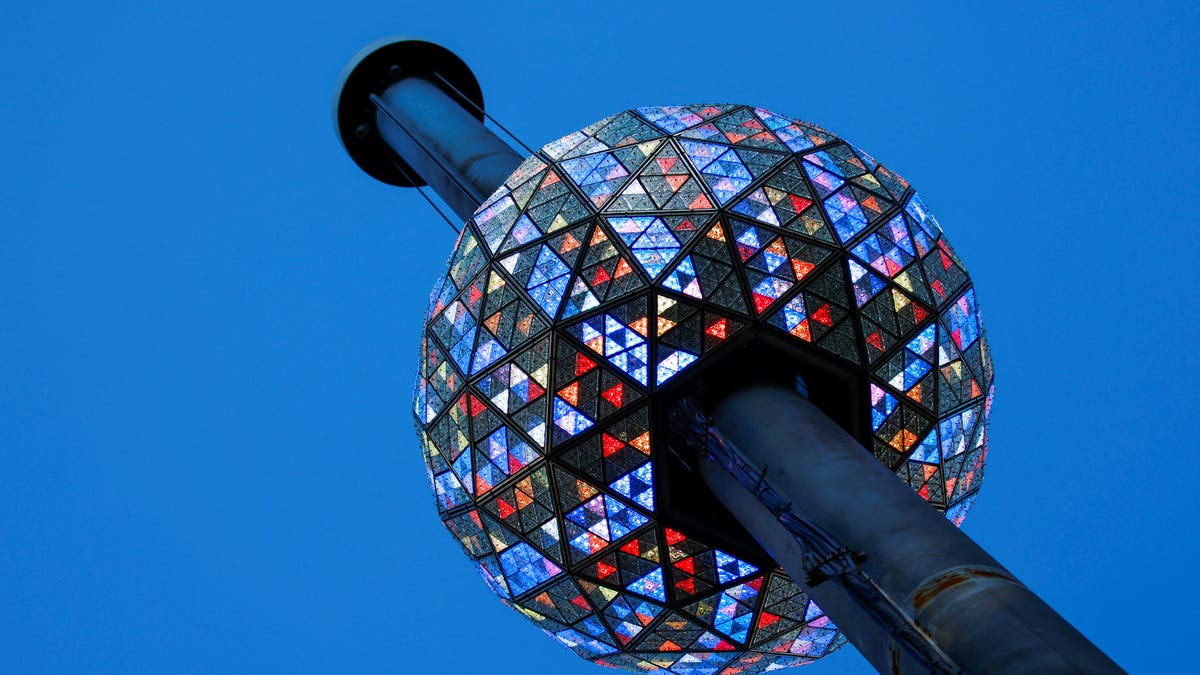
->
xmin=0 ymin=0 xmax=1200 ymax=675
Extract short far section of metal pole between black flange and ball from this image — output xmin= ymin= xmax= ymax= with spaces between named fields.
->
xmin=371 ymin=77 xmax=524 ymax=220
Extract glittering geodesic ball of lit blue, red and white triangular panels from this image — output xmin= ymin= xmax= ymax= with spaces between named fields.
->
xmin=415 ymin=104 xmax=992 ymax=673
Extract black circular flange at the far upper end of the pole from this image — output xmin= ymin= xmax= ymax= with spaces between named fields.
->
xmin=334 ymin=36 xmax=484 ymax=187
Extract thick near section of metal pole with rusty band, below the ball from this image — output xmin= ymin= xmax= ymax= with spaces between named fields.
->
xmin=701 ymin=386 xmax=1122 ymax=673
